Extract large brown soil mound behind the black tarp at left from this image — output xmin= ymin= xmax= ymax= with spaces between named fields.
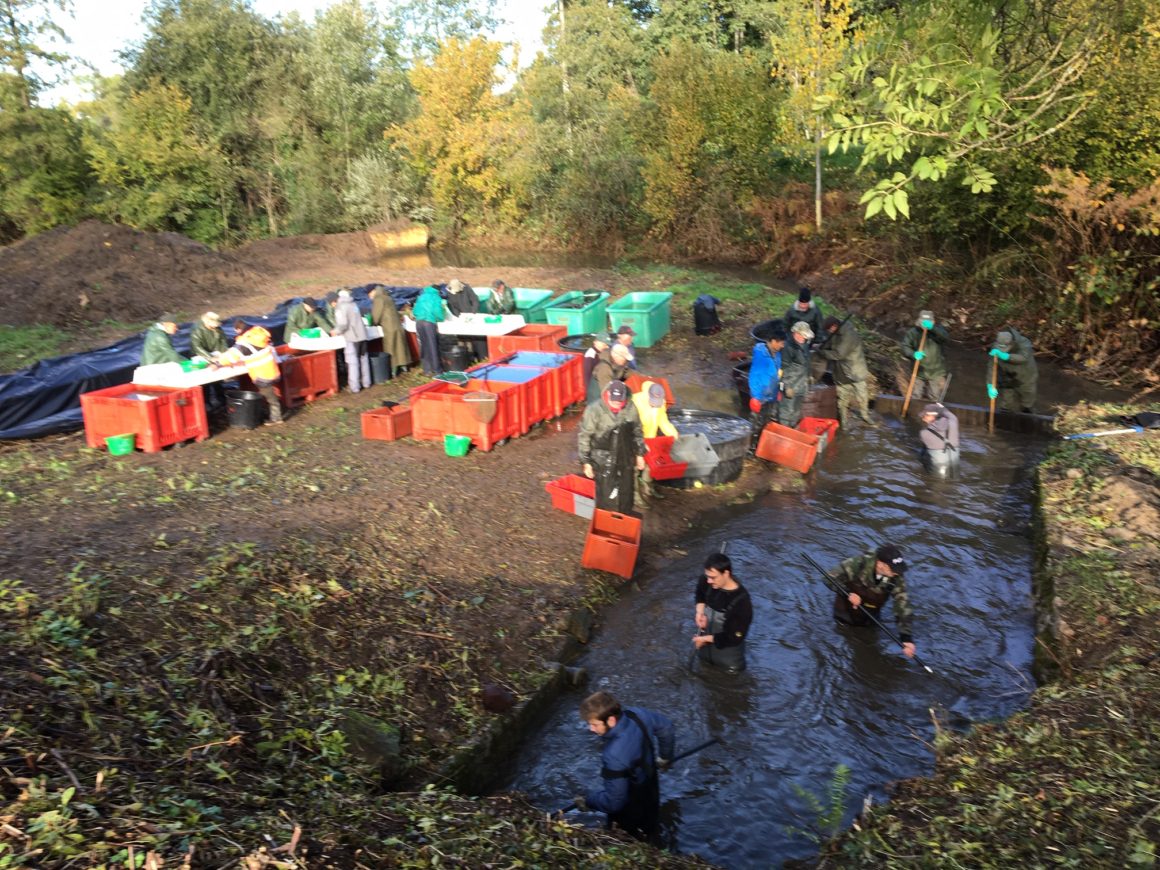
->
xmin=0 ymin=220 xmax=261 ymax=327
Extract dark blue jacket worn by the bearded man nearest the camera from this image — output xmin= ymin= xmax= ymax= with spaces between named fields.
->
xmin=585 ymin=706 xmax=673 ymax=813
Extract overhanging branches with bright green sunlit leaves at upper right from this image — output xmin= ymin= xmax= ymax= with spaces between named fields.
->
xmin=815 ymin=0 xmax=1107 ymax=219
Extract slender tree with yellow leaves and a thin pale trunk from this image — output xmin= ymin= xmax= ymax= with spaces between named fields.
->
xmin=770 ymin=0 xmax=863 ymax=232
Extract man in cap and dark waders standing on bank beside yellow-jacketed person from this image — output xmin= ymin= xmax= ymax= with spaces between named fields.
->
xmin=579 ymin=380 xmax=646 ymax=514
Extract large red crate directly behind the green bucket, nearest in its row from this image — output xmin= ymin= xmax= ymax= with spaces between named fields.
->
xmin=411 ymin=380 xmax=522 ymax=450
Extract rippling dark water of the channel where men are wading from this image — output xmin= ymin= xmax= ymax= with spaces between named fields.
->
xmin=506 ymin=420 xmax=1041 ymax=868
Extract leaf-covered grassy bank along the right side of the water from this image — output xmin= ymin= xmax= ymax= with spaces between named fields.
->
xmin=818 ymin=406 xmax=1160 ymax=868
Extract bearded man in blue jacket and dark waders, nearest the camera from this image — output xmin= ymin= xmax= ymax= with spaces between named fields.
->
xmin=574 ymin=691 xmax=674 ymax=843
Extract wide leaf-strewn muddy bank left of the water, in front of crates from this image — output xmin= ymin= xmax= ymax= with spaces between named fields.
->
xmin=0 ymin=270 xmax=788 ymax=868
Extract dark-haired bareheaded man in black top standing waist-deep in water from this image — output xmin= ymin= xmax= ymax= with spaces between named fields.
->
xmin=693 ymin=553 xmax=753 ymax=674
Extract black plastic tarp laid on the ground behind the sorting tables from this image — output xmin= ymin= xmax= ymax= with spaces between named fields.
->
xmin=0 ymin=284 xmax=421 ymax=440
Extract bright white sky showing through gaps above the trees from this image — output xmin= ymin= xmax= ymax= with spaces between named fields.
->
xmin=41 ymin=0 xmax=548 ymax=106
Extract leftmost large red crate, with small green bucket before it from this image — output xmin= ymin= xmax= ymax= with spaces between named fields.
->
xmin=80 ymin=384 xmax=210 ymax=454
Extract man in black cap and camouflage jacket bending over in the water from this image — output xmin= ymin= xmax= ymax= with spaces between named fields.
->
xmin=829 ymin=544 xmax=915 ymax=659
